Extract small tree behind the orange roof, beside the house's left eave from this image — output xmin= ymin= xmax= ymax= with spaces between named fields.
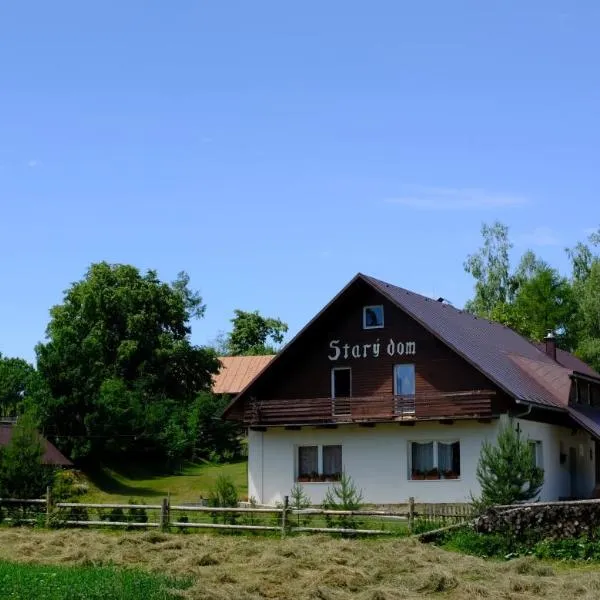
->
xmin=227 ymin=309 xmax=288 ymax=356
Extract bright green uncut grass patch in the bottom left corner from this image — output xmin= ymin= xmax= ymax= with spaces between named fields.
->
xmin=0 ymin=562 xmax=192 ymax=600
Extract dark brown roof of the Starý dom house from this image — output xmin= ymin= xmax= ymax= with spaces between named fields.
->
xmin=226 ymin=273 xmax=600 ymax=412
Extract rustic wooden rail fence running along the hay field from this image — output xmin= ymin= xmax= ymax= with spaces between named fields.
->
xmin=0 ymin=493 xmax=472 ymax=536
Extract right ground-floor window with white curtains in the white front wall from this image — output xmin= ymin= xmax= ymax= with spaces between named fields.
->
xmin=408 ymin=441 xmax=460 ymax=479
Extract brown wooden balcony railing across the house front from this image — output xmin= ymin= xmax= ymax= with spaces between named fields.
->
xmin=244 ymin=390 xmax=495 ymax=426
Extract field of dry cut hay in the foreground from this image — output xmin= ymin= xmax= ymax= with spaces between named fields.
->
xmin=0 ymin=529 xmax=600 ymax=600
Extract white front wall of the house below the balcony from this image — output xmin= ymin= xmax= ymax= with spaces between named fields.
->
xmin=248 ymin=421 xmax=497 ymax=504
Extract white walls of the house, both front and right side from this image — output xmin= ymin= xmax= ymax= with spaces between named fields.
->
xmin=248 ymin=420 xmax=594 ymax=504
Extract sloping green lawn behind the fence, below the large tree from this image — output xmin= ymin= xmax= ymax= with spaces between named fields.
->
xmin=80 ymin=461 xmax=248 ymax=504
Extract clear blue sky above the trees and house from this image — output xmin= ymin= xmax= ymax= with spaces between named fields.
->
xmin=0 ymin=0 xmax=600 ymax=360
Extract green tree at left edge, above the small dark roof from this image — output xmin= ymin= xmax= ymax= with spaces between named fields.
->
xmin=0 ymin=353 xmax=47 ymax=417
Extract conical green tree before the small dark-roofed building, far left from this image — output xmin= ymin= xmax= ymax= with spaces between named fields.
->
xmin=0 ymin=414 xmax=55 ymax=498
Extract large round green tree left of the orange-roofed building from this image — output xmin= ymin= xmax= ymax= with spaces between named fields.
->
xmin=36 ymin=262 xmax=218 ymax=459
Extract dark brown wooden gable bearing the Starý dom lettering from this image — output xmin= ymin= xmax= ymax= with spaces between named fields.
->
xmin=227 ymin=277 xmax=498 ymax=416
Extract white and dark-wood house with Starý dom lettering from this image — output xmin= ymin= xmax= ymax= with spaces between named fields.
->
xmin=225 ymin=274 xmax=600 ymax=504
